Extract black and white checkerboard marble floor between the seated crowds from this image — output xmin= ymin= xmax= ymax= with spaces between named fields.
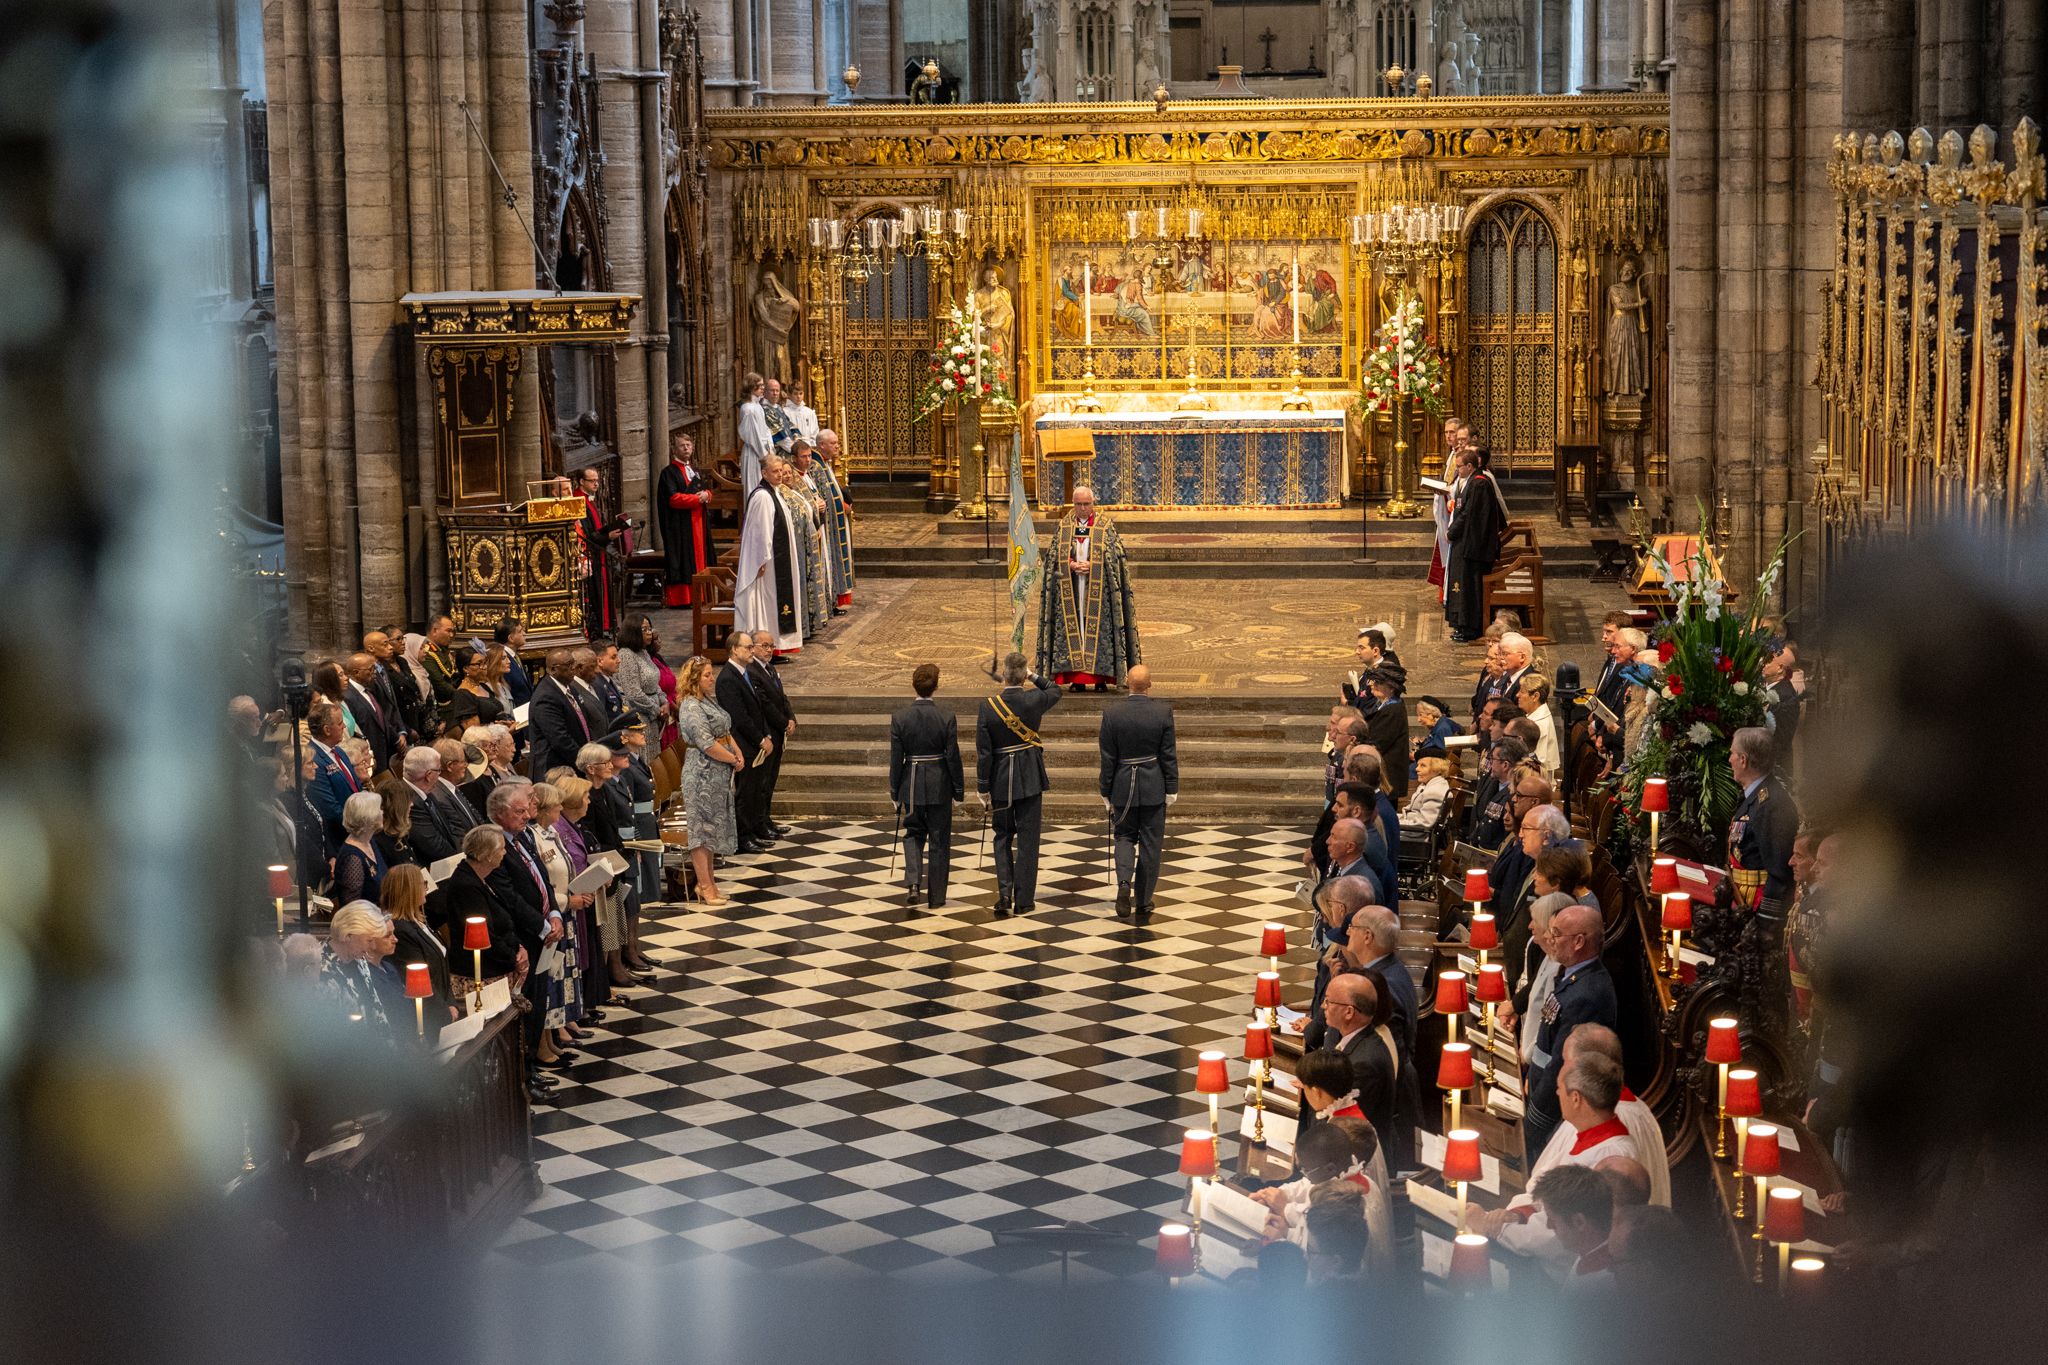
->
xmin=494 ymin=822 xmax=1307 ymax=1281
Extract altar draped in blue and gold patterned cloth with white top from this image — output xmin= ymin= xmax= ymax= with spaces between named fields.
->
xmin=1036 ymin=409 xmax=1346 ymax=508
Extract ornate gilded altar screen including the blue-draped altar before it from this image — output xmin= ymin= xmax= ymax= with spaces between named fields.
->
xmin=709 ymin=96 xmax=1669 ymax=508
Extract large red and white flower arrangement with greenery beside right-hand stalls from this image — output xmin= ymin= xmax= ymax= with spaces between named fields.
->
xmin=1624 ymin=523 xmax=1790 ymax=847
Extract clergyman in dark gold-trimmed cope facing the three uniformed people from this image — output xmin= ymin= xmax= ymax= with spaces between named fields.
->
xmin=1038 ymin=483 xmax=1143 ymax=692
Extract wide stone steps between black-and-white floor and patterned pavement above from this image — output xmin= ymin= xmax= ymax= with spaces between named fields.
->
xmin=776 ymin=692 xmax=1329 ymax=833
